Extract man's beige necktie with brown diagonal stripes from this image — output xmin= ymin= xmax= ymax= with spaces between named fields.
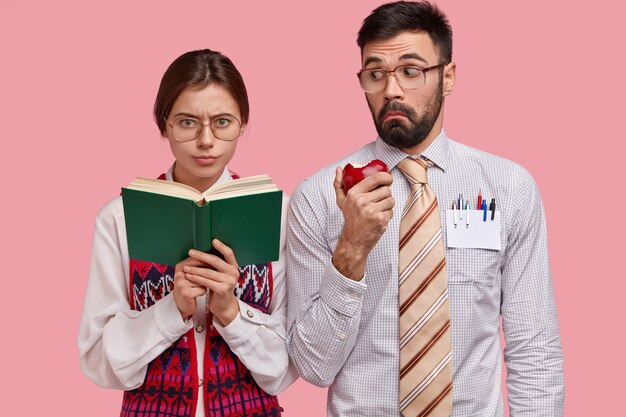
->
xmin=398 ymin=158 xmax=452 ymax=417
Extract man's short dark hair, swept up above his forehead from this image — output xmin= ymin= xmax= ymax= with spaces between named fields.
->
xmin=356 ymin=1 xmax=452 ymax=63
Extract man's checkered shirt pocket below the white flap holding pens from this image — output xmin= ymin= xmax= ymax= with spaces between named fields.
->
xmin=446 ymin=248 xmax=502 ymax=287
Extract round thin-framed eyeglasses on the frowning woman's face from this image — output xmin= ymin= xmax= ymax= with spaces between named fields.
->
xmin=165 ymin=114 xmax=242 ymax=142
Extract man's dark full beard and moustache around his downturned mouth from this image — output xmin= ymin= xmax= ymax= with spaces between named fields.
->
xmin=367 ymin=81 xmax=443 ymax=149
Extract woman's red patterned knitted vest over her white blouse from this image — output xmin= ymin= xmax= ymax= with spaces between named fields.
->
xmin=120 ymin=171 xmax=282 ymax=417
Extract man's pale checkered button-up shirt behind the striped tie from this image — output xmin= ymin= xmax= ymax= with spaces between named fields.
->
xmin=287 ymin=132 xmax=564 ymax=417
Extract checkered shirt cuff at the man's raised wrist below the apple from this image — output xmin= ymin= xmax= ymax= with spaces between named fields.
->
xmin=319 ymin=262 xmax=367 ymax=317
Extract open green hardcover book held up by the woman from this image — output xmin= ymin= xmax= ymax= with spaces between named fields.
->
xmin=122 ymin=175 xmax=283 ymax=266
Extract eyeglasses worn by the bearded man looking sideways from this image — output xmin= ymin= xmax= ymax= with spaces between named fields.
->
xmin=356 ymin=64 xmax=446 ymax=93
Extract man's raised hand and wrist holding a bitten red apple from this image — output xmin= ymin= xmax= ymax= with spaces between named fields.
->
xmin=332 ymin=160 xmax=395 ymax=281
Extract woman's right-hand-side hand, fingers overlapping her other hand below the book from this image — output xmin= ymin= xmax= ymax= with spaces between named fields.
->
xmin=183 ymin=239 xmax=239 ymax=326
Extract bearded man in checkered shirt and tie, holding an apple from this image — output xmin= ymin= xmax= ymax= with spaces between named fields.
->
xmin=287 ymin=2 xmax=563 ymax=417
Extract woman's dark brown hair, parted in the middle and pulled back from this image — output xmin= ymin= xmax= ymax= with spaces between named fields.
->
xmin=154 ymin=49 xmax=250 ymax=135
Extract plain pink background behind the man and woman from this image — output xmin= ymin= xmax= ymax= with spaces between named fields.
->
xmin=0 ymin=0 xmax=626 ymax=417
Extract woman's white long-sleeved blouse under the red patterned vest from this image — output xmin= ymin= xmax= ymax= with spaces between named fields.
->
xmin=78 ymin=166 xmax=297 ymax=416
